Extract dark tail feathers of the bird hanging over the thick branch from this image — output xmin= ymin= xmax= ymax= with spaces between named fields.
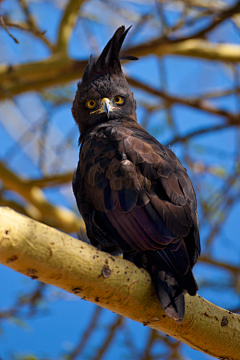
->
xmin=147 ymin=250 xmax=197 ymax=323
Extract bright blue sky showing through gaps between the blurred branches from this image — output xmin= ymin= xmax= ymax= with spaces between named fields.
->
xmin=0 ymin=0 xmax=240 ymax=360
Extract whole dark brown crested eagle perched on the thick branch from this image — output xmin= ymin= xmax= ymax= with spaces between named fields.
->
xmin=72 ymin=26 xmax=200 ymax=322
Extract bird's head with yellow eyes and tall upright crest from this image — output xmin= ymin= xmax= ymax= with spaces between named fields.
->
xmin=72 ymin=26 xmax=137 ymax=138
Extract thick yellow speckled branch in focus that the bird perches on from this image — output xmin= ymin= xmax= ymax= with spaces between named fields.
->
xmin=0 ymin=208 xmax=240 ymax=360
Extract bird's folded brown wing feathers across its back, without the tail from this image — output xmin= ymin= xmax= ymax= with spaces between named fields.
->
xmin=77 ymin=124 xmax=200 ymax=264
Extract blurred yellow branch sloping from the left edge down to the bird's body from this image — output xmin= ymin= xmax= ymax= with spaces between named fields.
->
xmin=0 ymin=162 xmax=84 ymax=232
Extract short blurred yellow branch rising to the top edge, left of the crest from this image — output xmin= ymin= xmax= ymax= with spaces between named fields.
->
xmin=54 ymin=0 xmax=85 ymax=54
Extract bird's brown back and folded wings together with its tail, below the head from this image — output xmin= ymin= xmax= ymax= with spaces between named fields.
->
xmin=76 ymin=124 xmax=200 ymax=322
